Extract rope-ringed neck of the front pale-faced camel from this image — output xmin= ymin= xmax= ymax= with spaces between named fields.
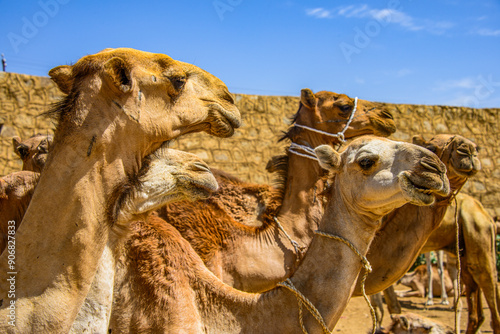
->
xmin=203 ymin=181 xmax=376 ymax=333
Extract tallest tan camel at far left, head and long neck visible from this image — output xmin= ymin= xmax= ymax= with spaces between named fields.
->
xmin=0 ymin=49 xmax=240 ymax=333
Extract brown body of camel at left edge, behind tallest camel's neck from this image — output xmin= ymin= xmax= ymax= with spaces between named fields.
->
xmin=0 ymin=171 xmax=40 ymax=254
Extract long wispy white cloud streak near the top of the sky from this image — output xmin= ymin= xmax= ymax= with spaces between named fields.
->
xmin=306 ymin=4 xmax=454 ymax=34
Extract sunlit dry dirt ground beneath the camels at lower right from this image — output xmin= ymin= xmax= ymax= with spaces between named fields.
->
xmin=333 ymin=286 xmax=493 ymax=334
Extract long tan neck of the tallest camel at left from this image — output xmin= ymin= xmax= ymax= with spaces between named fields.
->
xmin=0 ymin=118 xmax=146 ymax=333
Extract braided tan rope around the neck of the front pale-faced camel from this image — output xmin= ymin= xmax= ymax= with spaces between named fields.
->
xmin=277 ymin=231 xmax=377 ymax=334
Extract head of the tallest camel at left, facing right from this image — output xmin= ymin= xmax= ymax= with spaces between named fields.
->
xmin=49 ymin=48 xmax=241 ymax=146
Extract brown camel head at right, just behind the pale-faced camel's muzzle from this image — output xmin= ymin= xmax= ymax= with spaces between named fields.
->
xmin=413 ymin=134 xmax=481 ymax=181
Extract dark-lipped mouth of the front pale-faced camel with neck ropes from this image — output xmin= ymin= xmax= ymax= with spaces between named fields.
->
xmin=398 ymin=172 xmax=449 ymax=206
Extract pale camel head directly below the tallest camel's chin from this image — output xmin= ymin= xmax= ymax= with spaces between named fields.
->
xmin=108 ymin=145 xmax=218 ymax=227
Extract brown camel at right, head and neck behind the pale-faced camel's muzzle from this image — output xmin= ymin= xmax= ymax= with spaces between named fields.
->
xmin=355 ymin=134 xmax=481 ymax=295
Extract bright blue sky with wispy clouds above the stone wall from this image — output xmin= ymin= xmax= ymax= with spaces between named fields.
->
xmin=0 ymin=0 xmax=500 ymax=108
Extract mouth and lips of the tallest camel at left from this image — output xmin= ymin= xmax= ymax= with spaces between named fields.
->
xmin=207 ymin=103 xmax=241 ymax=138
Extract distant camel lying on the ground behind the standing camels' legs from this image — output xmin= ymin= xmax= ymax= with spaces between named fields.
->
xmin=397 ymin=264 xmax=453 ymax=297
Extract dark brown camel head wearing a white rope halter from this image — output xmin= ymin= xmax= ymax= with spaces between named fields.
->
xmin=288 ymin=88 xmax=396 ymax=145
